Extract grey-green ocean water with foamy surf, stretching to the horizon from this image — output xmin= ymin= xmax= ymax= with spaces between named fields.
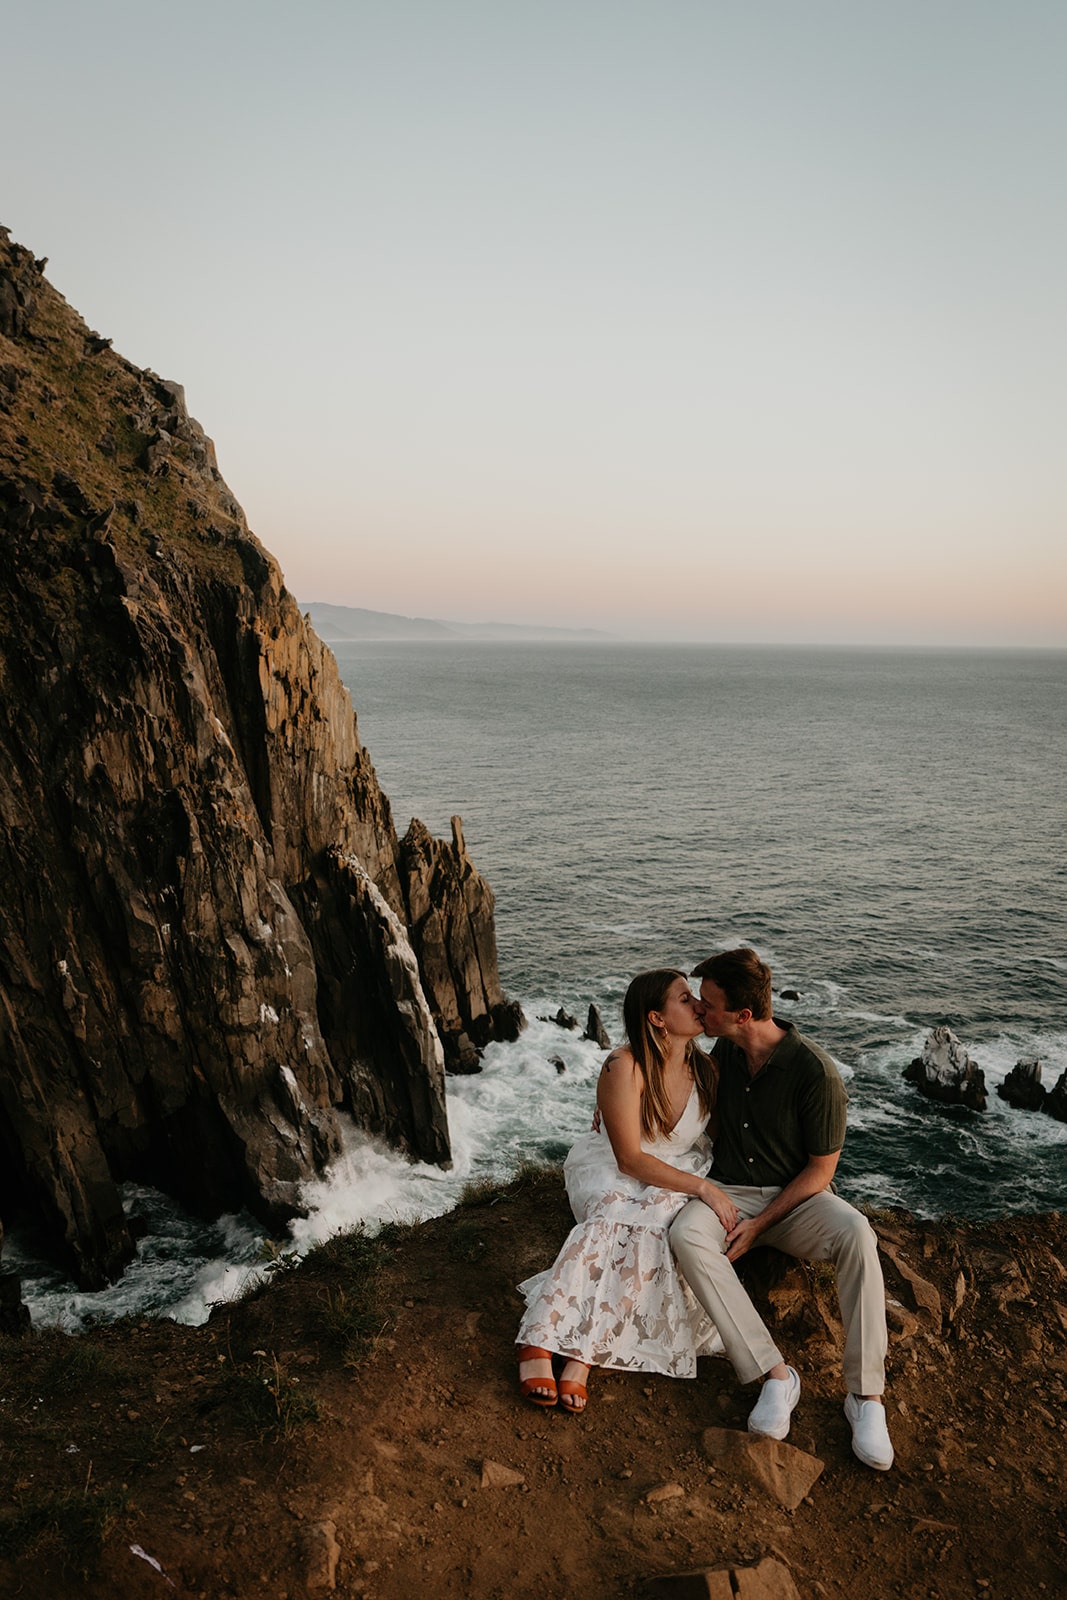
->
xmin=5 ymin=642 xmax=1067 ymax=1325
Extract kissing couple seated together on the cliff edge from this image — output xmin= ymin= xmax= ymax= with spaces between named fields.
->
xmin=517 ymin=947 xmax=893 ymax=1470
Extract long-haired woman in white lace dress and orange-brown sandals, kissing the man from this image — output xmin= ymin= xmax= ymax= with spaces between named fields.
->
xmin=517 ymin=968 xmax=737 ymax=1411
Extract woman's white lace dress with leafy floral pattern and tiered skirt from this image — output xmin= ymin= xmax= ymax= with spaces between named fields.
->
xmin=517 ymin=1086 xmax=723 ymax=1378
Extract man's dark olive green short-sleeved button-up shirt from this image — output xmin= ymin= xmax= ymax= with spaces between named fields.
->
xmin=709 ymin=1018 xmax=848 ymax=1189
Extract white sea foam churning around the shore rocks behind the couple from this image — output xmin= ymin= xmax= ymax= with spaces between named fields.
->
xmin=5 ymin=1004 xmax=1067 ymax=1328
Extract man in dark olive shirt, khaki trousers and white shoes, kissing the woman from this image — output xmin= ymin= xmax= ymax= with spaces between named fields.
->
xmin=670 ymin=949 xmax=893 ymax=1470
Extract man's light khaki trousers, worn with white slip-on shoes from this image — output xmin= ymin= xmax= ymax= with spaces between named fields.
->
xmin=670 ymin=1184 xmax=886 ymax=1395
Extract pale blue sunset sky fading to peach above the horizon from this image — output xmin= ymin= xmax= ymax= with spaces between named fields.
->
xmin=0 ymin=0 xmax=1067 ymax=648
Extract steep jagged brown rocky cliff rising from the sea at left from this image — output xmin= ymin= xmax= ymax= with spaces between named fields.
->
xmin=0 ymin=230 xmax=522 ymax=1285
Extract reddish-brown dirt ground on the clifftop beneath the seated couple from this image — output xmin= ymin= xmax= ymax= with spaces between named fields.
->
xmin=0 ymin=1173 xmax=1067 ymax=1600
